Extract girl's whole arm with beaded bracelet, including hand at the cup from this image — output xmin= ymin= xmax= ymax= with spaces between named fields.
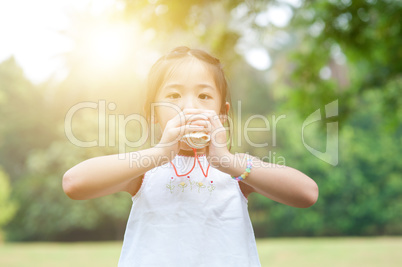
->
xmin=204 ymin=110 xmax=318 ymax=208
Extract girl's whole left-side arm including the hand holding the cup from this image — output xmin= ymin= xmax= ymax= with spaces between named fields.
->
xmin=63 ymin=109 xmax=207 ymax=199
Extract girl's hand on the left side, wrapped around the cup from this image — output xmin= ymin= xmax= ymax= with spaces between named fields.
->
xmin=156 ymin=109 xmax=210 ymax=159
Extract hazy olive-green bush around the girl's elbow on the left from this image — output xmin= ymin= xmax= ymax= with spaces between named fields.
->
xmin=7 ymin=131 xmax=130 ymax=240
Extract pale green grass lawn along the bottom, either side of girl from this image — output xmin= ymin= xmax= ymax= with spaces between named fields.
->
xmin=0 ymin=237 xmax=402 ymax=267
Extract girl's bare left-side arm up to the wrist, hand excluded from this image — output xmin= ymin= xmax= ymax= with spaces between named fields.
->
xmin=63 ymin=147 xmax=169 ymax=200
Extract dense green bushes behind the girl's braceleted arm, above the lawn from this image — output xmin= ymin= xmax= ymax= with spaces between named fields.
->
xmin=250 ymin=91 xmax=402 ymax=236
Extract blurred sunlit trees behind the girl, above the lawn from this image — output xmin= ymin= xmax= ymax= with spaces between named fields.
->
xmin=0 ymin=0 xmax=402 ymax=266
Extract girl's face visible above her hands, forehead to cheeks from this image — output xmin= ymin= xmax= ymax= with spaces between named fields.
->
xmin=155 ymin=58 xmax=229 ymax=150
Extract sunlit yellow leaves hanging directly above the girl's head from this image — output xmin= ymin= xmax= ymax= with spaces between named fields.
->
xmin=125 ymin=0 xmax=243 ymax=63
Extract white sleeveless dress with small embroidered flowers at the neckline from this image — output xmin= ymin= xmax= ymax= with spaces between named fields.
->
xmin=118 ymin=155 xmax=261 ymax=267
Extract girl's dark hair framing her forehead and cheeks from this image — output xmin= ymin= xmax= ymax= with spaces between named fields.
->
xmin=144 ymin=46 xmax=232 ymax=147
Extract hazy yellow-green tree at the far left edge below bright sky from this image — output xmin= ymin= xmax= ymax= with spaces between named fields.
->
xmin=0 ymin=57 xmax=54 ymax=181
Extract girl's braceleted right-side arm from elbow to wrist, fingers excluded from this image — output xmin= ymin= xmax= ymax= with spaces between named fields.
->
xmin=218 ymin=153 xmax=318 ymax=208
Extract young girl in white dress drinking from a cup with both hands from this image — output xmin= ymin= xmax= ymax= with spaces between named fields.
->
xmin=63 ymin=47 xmax=318 ymax=267
